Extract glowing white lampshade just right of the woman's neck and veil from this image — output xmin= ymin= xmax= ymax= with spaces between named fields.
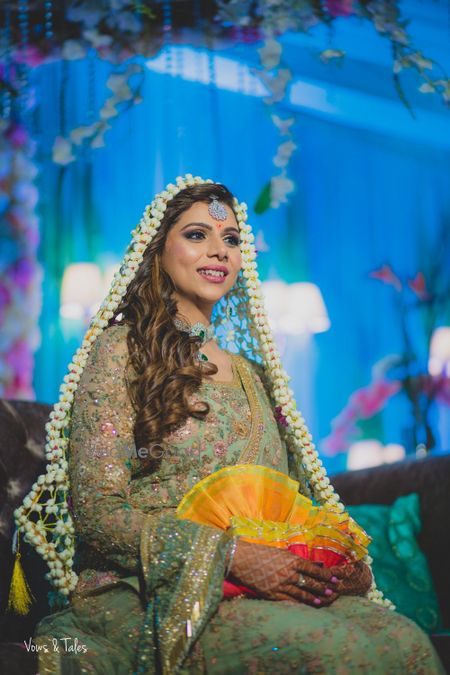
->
xmin=262 ymin=281 xmax=330 ymax=335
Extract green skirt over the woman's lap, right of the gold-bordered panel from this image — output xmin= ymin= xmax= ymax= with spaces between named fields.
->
xmin=195 ymin=596 xmax=444 ymax=675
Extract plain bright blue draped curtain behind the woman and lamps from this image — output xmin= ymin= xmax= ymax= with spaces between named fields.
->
xmin=32 ymin=10 xmax=450 ymax=476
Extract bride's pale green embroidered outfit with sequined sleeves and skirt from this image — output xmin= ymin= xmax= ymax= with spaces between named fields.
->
xmin=34 ymin=326 xmax=444 ymax=675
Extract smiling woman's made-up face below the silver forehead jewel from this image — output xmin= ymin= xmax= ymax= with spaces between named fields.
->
xmin=161 ymin=202 xmax=242 ymax=307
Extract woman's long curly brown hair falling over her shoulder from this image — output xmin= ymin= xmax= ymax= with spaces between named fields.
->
xmin=109 ymin=183 xmax=234 ymax=472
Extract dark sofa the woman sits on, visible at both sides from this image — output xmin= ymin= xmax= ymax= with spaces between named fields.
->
xmin=0 ymin=399 xmax=450 ymax=675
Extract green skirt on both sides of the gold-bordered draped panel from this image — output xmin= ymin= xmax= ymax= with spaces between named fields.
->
xmin=34 ymin=586 xmax=444 ymax=675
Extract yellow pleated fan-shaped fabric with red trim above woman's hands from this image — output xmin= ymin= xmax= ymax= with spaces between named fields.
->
xmin=177 ymin=464 xmax=370 ymax=595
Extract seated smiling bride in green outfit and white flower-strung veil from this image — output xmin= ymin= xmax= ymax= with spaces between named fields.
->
xmin=16 ymin=174 xmax=444 ymax=675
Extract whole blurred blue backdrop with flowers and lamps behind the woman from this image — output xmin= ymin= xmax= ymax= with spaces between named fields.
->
xmin=0 ymin=0 xmax=450 ymax=470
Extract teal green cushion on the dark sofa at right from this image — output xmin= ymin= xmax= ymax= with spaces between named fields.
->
xmin=347 ymin=493 xmax=442 ymax=633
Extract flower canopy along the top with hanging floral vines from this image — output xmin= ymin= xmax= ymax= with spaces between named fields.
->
xmin=0 ymin=0 xmax=450 ymax=193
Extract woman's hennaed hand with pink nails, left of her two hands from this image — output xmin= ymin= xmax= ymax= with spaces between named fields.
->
xmin=229 ymin=539 xmax=340 ymax=607
